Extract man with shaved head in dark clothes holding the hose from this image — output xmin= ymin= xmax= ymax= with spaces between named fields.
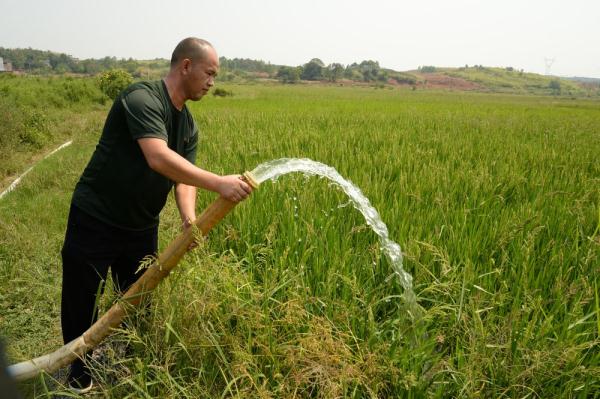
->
xmin=61 ymin=38 xmax=252 ymax=393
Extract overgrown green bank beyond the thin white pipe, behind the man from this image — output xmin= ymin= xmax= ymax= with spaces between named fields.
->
xmin=0 ymin=74 xmax=107 ymax=189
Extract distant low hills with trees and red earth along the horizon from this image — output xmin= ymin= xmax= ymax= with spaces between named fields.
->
xmin=0 ymin=47 xmax=600 ymax=97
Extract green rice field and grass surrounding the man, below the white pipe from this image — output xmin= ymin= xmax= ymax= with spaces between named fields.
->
xmin=0 ymin=79 xmax=600 ymax=398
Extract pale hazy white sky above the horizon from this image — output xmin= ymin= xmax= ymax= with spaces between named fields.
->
xmin=0 ymin=0 xmax=600 ymax=78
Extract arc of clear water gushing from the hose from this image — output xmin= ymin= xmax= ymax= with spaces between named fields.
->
xmin=252 ymin=158 xmax=417 ymax=311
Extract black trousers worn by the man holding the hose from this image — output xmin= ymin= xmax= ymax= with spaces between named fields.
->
xmin=61 ymin=205 xmax=158 ymax=378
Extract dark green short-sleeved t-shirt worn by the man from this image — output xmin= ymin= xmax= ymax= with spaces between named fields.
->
xmin=73 ymin=80 xmax=198 ymax=230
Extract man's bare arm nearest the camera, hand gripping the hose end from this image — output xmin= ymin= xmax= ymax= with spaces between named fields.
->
xmin=138 ymin=137 xmax=252 ymax=202
